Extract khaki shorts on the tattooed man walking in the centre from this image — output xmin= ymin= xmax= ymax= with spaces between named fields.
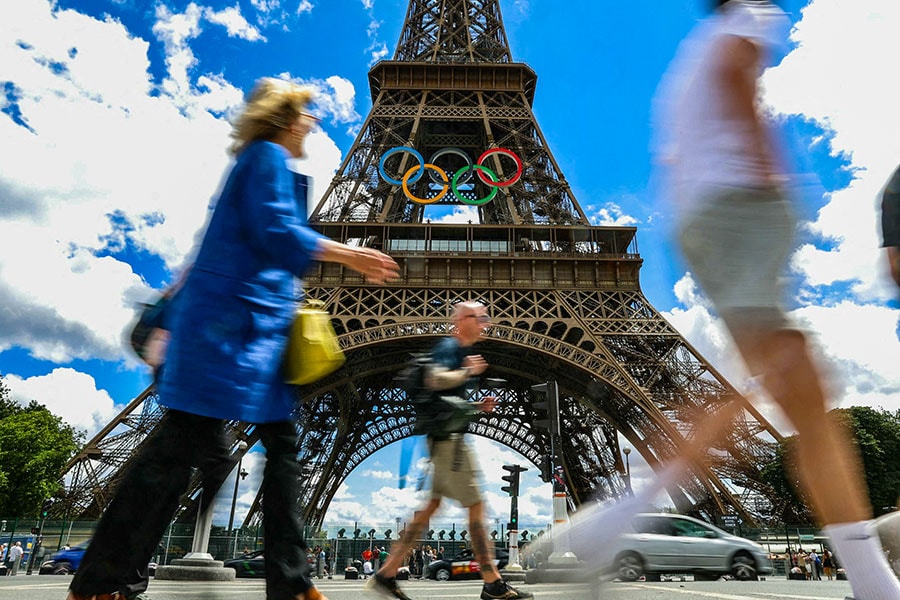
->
xmin=428 ymin=433 xmax=482 ymax=508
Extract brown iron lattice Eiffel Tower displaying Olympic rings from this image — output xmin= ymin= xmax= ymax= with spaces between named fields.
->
xmin=58 ymin=0 xmax=789 ymax=527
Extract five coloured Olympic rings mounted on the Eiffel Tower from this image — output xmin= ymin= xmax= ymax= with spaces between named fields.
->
xmin=378 ymin=146 xmax=524 ymax=206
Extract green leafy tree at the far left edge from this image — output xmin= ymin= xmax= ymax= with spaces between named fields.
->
xmin=0 ymin=376 xmax=84 ymax=517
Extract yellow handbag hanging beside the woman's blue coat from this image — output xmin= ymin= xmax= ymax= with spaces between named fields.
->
xmin=284 ymin=299 xmax=347 ymax=385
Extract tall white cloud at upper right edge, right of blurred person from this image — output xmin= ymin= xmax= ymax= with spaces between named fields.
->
xmin=764 ymin=0 xmax=900 ymax=301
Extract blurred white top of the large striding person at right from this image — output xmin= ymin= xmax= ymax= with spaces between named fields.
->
xmin=651 ymin=0 xmax=790 ymax=214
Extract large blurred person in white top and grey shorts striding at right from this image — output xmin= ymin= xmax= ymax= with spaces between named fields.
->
xmin=656 ymin=0 xmax=900 ymax=600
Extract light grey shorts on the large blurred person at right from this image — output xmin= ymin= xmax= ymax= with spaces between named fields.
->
xmin=678 ymin=187 xmax=797 ymax=331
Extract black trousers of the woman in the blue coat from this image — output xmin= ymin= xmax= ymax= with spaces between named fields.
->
xmin=70 ymin=410 xmax=313 ymax=600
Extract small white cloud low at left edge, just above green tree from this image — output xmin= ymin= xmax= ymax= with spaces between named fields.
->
xmin=4 ymin=368 xmax=122 ymax=439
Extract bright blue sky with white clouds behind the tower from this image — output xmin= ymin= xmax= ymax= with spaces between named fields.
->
xmin=0 ymin=0 xmax=900 ymax=527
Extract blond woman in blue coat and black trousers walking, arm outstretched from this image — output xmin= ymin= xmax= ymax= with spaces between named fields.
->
xmin=69 ymin=79 xmax=398 ymax=600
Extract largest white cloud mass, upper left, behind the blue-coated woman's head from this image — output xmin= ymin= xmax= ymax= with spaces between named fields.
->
xmin=0 ymin=0 xmax=355 ymax=365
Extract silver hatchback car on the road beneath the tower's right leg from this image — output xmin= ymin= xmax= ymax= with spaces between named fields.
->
xmin=612 ymin=513 xmax=773 ymax=581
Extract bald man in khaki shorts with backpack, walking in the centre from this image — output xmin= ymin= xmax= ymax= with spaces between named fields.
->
xmin=367 ymin=301 xmax=533 ymax=600
